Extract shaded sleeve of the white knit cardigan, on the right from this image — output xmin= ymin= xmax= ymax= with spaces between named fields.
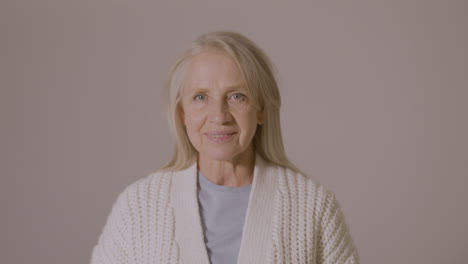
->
xmin=317 ymin=190 xmax=359 ymax=264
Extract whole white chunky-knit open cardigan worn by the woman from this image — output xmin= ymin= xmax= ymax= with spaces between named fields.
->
xmin=91 ymin=154 xmax=359 ymax=264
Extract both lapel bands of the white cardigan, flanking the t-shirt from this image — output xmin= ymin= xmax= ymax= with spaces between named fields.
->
xmin=171 ymin=154 xmax=278 ymax=264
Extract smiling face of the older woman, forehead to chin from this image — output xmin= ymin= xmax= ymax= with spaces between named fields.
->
xmin=181 ymin=51 xmax=258 ymax=161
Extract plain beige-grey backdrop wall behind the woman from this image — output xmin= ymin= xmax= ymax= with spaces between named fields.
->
xmin=0 ymin=0 xmax=468 ymax=264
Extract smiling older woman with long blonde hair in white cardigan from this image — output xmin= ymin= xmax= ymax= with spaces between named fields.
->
xmin=91 ymin=32 xmax=359 ymax=264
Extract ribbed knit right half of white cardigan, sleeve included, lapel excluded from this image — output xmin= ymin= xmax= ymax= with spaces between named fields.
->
xmin=270 ymin=169 xmax=359 ymax=264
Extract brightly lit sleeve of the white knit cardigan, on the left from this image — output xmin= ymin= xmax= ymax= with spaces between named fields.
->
xmin=91 ymin=191 xmax=131 ymax=264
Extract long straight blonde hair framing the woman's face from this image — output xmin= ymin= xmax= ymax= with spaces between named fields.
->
xmin=162 ymin=31 xmax=299 ymax=171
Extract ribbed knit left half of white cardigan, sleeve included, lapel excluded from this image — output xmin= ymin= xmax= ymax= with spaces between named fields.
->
xmin=91 ymin=174 xmax=179 ymax=264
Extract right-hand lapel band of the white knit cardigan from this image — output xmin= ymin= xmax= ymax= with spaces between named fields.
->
xmin=237 ymin=154 xmax=278 ymax=264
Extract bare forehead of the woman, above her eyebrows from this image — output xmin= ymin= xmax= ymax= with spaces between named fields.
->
xmin=184 ymin=51 xmax=243 ymax=89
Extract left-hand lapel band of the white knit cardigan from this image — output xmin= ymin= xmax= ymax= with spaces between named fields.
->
xmin=171 ymin=162 xmax=210 ymax=264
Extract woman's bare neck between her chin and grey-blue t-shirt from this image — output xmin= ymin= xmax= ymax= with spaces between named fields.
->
xmin=198 ymin=148 xmax=255 ymax=187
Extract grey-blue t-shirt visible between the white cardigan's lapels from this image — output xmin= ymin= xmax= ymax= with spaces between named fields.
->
xmin=198 ymin=172 xmax=252 ymax=264
